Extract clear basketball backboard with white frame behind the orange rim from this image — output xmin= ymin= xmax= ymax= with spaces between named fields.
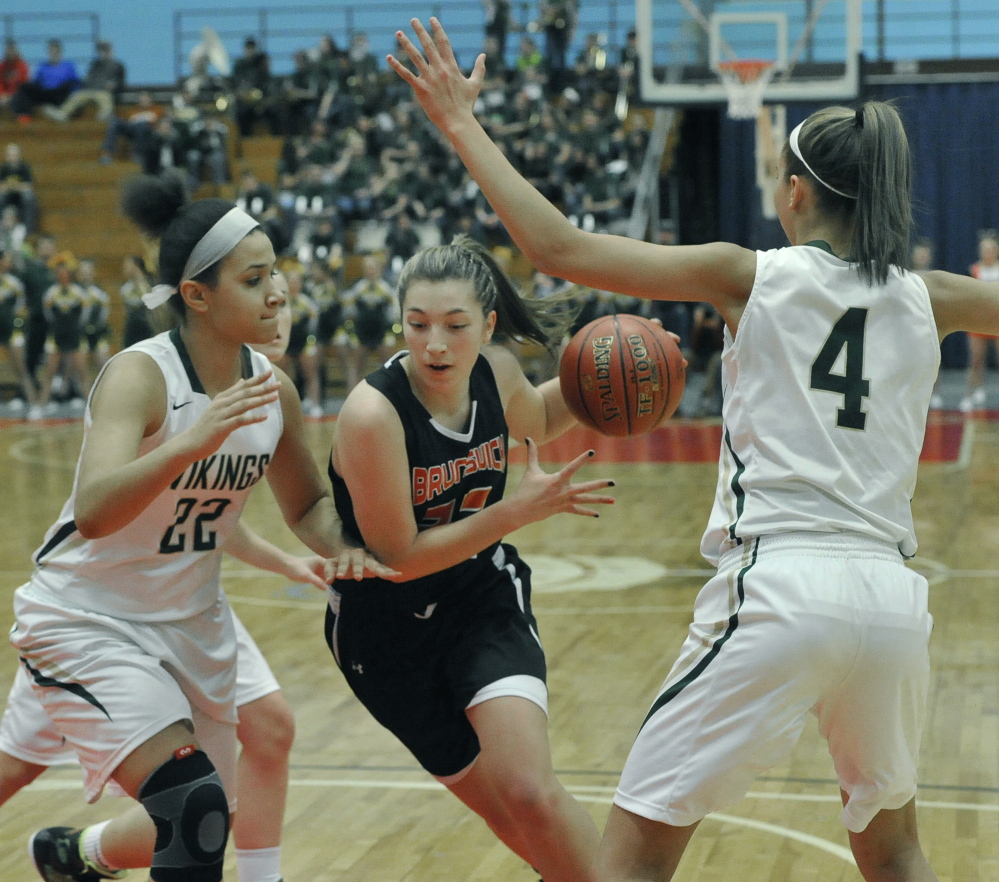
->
xmin=635 ymin=0 xmax=862 ymax=106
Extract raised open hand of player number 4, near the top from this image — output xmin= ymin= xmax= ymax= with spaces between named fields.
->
xmin=386 ymin=17 xmax=486 ymax=130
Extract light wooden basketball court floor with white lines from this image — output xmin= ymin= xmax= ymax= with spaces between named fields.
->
xmin=0 ymin=413 xmax=999 ymax=882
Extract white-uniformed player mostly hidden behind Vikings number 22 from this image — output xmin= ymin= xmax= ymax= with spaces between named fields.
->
xmin=0 ymin=296 xmax=316 ymax=882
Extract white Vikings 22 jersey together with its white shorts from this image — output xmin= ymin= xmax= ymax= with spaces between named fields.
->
xmin=11 ymin=330 xmax=283 ymax=801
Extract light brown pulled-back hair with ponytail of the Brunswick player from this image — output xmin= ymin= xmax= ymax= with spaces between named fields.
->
xmin=398 ymin=235 xmax=575 ymax=356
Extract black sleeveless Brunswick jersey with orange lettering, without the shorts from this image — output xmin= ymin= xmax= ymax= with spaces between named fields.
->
xmin=329 ymin=352 xmax=508 ymax=613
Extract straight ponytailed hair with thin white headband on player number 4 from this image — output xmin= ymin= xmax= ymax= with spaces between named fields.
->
xmin=784 ymin=101 xmax=912 ymax=285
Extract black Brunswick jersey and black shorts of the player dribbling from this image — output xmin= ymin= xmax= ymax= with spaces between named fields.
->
xmin=326 ymin=352 xmax=547 ymax=783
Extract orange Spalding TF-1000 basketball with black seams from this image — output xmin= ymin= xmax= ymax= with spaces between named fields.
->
xmin=559 ymin=315 xmax=687 ymax=436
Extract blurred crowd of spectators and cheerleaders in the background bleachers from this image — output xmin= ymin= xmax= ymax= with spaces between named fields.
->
xmin=0 ymin=18 xmax=714 ymax=415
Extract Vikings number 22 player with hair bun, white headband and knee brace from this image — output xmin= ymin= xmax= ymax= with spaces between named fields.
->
xmin=10 ymin=176 xmax=391 ymax=882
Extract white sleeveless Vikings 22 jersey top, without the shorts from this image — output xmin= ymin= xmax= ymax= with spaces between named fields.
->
xmin=29 ymin=331 xmax=284 ymax=621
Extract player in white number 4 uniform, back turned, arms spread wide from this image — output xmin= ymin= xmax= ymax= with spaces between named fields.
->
xmin=389 ymin=19 xmax=999 ymax=880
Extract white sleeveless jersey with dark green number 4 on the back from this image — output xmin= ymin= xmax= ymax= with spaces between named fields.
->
xmin=701 ymin=245 xmax=940 ymax=563
